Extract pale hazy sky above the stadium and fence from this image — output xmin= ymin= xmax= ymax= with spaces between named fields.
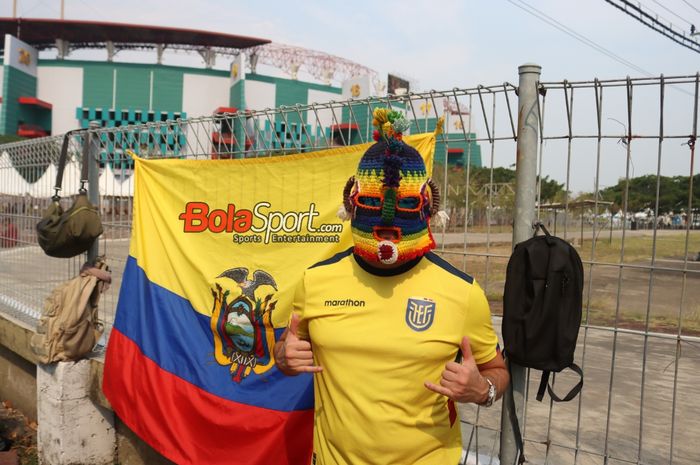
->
xmin=0 ymin=0 xmax=700 ymax=196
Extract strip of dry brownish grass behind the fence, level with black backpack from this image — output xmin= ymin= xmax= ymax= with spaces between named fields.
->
xmin=443 ymin=231 xmax=700 ymax=336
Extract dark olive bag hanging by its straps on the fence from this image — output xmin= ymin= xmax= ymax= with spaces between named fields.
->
xmin=36 ymin=131 xmax=102 ymax=258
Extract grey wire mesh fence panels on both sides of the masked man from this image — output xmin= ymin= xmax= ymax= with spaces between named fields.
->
xmin=0 ymin=76 xmax=700 ymax=464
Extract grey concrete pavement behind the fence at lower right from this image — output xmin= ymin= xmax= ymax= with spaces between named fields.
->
xmin=461 ymin=322 xmax=700 ymax=465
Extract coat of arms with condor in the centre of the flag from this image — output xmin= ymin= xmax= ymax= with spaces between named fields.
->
xmin=211 ymin=267 xmax=277 ymax=383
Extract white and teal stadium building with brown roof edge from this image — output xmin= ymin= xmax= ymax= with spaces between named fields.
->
xmin=0 ymin=18 xmax=481 ymax=166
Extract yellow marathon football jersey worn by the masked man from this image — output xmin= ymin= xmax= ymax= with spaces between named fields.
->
xmin=294 ymin=249 xmax=498 ymax=465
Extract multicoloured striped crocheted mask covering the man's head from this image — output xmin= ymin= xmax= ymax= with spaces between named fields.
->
xmin=344 ymin=109 xmax=440 ymax=265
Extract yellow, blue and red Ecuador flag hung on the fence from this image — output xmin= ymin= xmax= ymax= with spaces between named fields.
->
xmin=103 ymin=134 xmax=435 ymax=465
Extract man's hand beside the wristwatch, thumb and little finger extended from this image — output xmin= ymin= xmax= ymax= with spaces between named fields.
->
xmin=424 ymin=336 xmax=489 ymax=404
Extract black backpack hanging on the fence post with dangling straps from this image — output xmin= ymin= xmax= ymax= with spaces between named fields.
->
xmin=502 ymin=222 xmax=583 ymax=463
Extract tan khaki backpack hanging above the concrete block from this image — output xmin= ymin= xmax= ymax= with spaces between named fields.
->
xmin=30 ymin=258 xmax=112 ymax=363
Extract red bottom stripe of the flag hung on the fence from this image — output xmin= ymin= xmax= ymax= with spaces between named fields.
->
xmin=102 ymin=329 xmax=313 ymax=465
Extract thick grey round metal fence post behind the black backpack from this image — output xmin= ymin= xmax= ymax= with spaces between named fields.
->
xmin=500 ymin=63 xmax=542 ymax=465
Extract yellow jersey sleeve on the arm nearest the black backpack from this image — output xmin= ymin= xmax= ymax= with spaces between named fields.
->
xmin=463 ymin=281 xmax=498 ymax=365
